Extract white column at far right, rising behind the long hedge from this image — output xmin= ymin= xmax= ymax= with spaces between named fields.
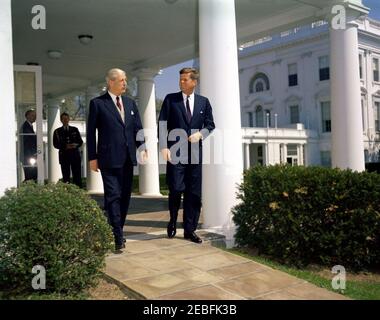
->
xmin=330 ymin=19 xmax=365 ymax=171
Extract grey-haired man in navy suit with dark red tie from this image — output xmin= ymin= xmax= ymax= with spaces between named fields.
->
xmin=87 ymin=69 xmax=147 ymax=252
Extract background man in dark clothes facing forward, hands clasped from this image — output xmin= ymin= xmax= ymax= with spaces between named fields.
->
xmin=53 ymin=112 xmax=83 ymax=188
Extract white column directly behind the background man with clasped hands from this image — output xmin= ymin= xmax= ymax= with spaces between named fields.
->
xmin=48 ymin=101 xmax=62 ymax=182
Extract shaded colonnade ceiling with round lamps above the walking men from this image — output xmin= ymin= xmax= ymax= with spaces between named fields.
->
xmin=12 ymin=0 xmax=368 ymax=96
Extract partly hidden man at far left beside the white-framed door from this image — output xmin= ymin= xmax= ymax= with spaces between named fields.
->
xmin=20 ymin=110 xmax=37 ymax=181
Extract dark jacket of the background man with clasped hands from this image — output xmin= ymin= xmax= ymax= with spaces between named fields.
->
xmin=53 ymin=126 xmax=83 ymax=163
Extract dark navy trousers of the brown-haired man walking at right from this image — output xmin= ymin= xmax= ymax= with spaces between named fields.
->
xmin=167 ymin=164 xmax=202 ymax=234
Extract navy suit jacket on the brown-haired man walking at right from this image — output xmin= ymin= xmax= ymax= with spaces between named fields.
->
xmin=158 ymin=92 xmax=215 ymax=163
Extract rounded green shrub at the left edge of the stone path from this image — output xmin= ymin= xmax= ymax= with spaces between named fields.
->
xmin=0 ymin=182 xmax=112 ymax=294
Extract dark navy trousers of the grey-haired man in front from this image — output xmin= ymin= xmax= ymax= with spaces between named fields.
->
xmin=100 ymin=156 xmax=133 ymax=245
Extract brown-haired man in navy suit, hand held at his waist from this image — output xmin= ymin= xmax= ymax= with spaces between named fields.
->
xmin=158 ymin=68 xmax=215 ymax=243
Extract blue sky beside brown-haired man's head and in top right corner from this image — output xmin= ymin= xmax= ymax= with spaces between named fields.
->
xmin=155 ymin=0 xmax=380 ymax=99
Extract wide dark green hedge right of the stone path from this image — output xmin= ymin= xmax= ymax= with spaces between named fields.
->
xmin=233 ymin=166 xmax=380 ymax=269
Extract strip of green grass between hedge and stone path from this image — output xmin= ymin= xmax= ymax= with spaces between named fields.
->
xmin=227 ymin=248 xmax=380 ymax=300
